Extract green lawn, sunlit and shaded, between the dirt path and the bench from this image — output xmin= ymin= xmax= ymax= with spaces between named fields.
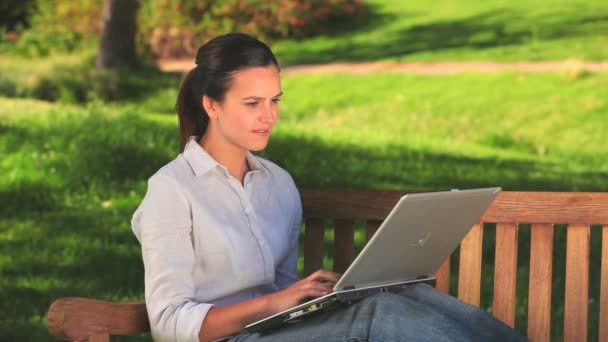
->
xmin=0 ymin=73 xmax=608 ymax=341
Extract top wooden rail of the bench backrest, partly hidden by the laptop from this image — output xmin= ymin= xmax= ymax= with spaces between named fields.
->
xmin=300 ymin=189 xmax=608 ymax=224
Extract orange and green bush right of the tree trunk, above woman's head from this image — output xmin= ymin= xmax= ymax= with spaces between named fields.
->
xmin=140 ymin=0 xmax=365 ymax=57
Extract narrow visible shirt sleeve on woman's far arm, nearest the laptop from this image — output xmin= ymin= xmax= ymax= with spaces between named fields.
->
xmin=275 ymin=179 xmax=302 ymax=290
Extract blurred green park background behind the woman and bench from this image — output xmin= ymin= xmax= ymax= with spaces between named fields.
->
xmin=0 ymin=0 xmax=608 ymax=341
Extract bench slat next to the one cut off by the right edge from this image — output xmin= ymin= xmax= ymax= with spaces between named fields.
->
xmin=564 ymin=225 xmax=590 ymax=342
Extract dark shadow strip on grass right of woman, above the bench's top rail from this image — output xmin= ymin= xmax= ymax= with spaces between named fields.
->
xmin=263 ymin=137 xmax=608 ymax=191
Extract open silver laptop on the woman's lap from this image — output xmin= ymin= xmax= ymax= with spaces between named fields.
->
xmin=245 ymin=187 xmax=501 ymax=333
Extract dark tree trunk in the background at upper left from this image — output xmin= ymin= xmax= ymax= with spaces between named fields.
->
xmin=96 ymin=0 xmax=138 ymax=68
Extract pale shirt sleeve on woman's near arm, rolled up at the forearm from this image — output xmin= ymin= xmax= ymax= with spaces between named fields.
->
xmin=132 ymin=174 xmax=213 ymax=342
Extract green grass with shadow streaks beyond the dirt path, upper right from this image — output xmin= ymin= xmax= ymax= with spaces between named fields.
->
xmin=273 ymin=0 xmax=608 ymax=64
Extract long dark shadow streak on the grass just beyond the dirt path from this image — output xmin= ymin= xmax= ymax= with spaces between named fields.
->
xmin=281 ymin=9 xmax=608 ymax=65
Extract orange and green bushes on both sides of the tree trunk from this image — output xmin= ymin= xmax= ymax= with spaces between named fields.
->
xmin=2 ymin=0 xmax=366 ymax=57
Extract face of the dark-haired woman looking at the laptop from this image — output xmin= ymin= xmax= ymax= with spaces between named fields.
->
xmin=207 ymin=65 xmax=282 ymax=151
